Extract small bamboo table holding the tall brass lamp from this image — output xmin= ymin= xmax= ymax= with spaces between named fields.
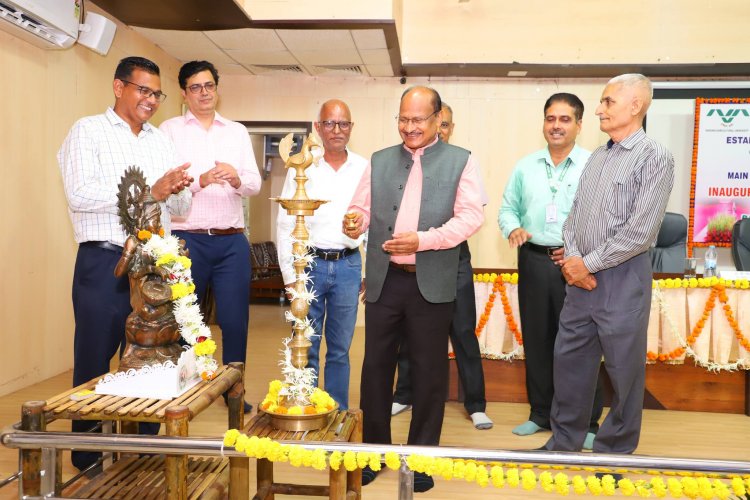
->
xmin=245 ymin=410 xmax=362 ymax=500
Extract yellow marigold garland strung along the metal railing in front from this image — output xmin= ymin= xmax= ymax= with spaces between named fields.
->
xmin=223 ymin=429 xmax=750 ymax=500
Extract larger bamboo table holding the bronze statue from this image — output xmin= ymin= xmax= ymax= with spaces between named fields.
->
xmin=21 ymin=363 xmax=249 ymax=500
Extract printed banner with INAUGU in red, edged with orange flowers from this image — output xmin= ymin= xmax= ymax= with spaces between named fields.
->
xmin=688 ymin=98 xmax=750 ymax=254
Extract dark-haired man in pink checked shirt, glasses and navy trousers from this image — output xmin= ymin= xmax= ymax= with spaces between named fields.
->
xmin=160 ymin=61 xmax=261 ymax=413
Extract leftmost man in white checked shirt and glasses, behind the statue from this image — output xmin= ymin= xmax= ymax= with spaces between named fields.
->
xmin=57 ymin=57 xmax=193 ymax=470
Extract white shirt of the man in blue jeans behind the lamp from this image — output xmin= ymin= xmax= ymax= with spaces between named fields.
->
xmin=276 ymin=149 xmax=367 ymax=283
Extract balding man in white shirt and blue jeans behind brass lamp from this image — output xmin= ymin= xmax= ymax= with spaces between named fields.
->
xmin=276 ymin=99 xmax=367 ymax=410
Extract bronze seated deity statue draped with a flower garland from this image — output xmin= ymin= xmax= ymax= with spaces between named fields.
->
xmin=115 ymin=167 xmax=187 ymax=371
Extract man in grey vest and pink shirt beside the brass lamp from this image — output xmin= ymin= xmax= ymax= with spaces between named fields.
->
xmin=343 ymin=87 xmax=484 ymax=492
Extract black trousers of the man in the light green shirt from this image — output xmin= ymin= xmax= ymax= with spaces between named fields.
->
xmin=518 ymin=245 xmax=603 ymax=433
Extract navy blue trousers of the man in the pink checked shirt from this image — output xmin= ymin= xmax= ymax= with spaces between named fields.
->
xmin=174 ymin=231 xmax=250 ymax=365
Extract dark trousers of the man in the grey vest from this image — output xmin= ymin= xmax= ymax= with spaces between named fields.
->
xmin=360 ymin=268 xmax=454 ymax=445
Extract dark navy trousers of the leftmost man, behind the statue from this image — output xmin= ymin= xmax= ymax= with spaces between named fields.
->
xmin=71 ymin=243 xmax=159 ymax=469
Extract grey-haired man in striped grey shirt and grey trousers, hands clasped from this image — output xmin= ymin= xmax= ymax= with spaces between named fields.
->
xmin=544 ymin=74 xmax=674 ymax=453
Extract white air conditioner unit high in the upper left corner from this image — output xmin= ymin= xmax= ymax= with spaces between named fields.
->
xmin=0 ymin=0 xmax=81 ymax=49
